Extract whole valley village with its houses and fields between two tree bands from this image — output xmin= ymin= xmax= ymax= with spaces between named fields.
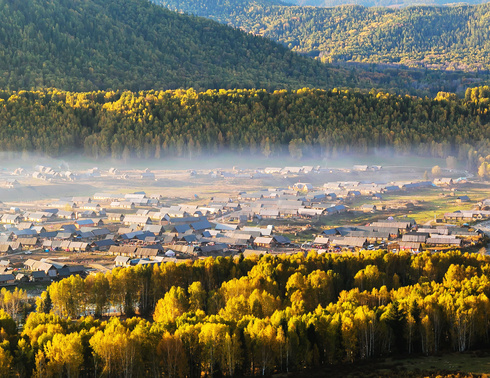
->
xmin=0 ymin=161 xmax=490 ymax=286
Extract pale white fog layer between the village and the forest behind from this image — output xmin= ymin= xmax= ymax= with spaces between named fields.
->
xmin=0 ymin=152 xmax=468 ymax=202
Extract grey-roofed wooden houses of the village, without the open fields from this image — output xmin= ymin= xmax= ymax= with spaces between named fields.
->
xmin=0 ymin=166 xmax=484 ymax=285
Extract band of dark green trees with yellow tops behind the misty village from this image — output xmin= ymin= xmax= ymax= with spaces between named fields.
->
xmin=0 ymin=87 xmax=490 ymax=168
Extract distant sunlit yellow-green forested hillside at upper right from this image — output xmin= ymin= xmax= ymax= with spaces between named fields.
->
xmin=154 ymin=0 xmax=490 ymax=70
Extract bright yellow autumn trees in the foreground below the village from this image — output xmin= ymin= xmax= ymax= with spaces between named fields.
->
xmin=0 ymin=251 xmax=490 ymax=377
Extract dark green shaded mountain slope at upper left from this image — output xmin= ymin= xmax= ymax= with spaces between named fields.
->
xmin=0 ymin=0 xmax=342 ymax=91
